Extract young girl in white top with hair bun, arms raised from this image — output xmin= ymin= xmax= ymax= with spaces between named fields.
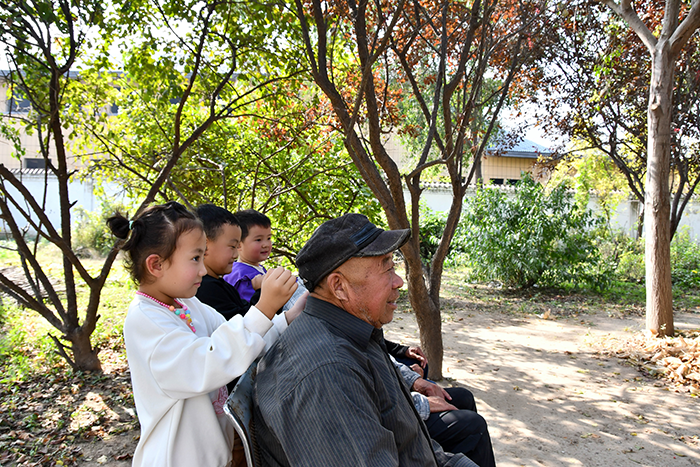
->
xmin=107 ymin=202 xmax=301 ymax=467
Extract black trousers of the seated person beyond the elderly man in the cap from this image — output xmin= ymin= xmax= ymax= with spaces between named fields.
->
xmin=425 ymin=388 xmax=496 ymax=467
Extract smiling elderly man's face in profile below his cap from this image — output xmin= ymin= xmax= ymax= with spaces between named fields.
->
xmin=338 ymin=253 xmax=403 ymax=328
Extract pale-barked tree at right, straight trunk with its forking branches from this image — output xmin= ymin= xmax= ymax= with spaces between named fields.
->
xmin=601 ymin=0 xmax=700 ymax=336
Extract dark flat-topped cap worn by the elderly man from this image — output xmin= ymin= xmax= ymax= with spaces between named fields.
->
xmin=296 ymin=214 xmax=411 ymax=290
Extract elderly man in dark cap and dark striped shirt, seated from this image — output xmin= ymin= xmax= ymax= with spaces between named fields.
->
xmin=254 ymin=214 xmax=476 ymax=467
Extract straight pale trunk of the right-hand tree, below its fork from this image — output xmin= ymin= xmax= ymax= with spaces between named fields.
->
xmin=644 ymin=40 xmax=675 ymax=336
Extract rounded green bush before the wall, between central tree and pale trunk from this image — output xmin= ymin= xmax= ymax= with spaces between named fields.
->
xmin=462 ymin=177 xmax=607 ymax=289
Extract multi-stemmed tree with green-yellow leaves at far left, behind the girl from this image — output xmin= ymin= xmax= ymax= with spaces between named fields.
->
xmin=0 ymin=0 xmax=288 ymax=370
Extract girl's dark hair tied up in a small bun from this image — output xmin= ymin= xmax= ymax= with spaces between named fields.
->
xmin=107 ymin=201 xmax=204 ymax=284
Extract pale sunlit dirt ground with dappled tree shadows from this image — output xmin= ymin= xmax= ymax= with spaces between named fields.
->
xmin=80 ymin=310 xmax=700 ymax=467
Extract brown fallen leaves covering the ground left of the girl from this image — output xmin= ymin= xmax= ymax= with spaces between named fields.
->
xmin=0 ymin=342 xmax=138 ymax=466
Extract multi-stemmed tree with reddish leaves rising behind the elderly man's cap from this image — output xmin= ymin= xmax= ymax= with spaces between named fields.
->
xmin=294 ymin=0 xmax=544 ymax=379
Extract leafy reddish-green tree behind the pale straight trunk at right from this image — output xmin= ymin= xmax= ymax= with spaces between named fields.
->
xmin=536 ymin=1 xmax=700 ymax=243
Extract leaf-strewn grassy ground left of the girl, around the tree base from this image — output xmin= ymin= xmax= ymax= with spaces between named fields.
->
xmin=0 ymin=262 xmax=138 ymax=466
